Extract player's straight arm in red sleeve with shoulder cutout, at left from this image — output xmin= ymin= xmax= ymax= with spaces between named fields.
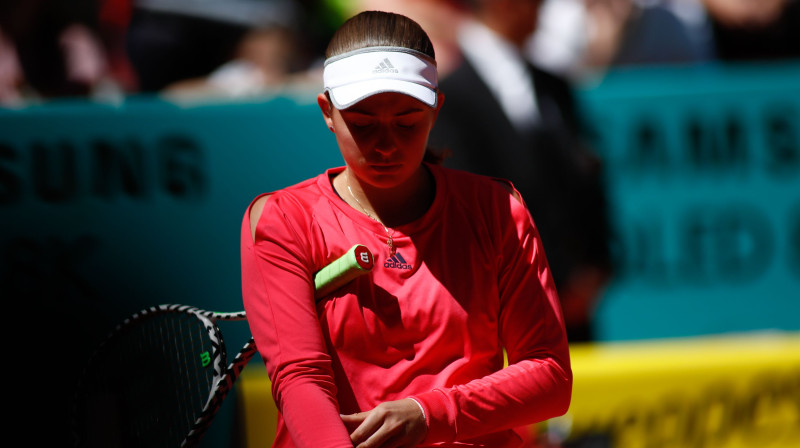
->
xmin=241 ymin=196 xmax=352 ymax=448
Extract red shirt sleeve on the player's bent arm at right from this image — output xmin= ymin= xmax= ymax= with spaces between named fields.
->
xmin=412 ymin=189 xmax=572 ymax=444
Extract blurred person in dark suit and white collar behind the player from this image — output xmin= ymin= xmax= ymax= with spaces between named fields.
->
xmin=430 ymin=0 xmax=611 ymax=342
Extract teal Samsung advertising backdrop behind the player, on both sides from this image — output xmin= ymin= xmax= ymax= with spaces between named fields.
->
xmin=0 ymin=63 xmax=800 ymax=446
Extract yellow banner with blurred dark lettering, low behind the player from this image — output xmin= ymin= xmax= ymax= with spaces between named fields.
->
xmin=236 ymin=332 xmax=800 ymax=448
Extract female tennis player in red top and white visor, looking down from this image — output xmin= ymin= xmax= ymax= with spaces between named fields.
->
xmin=242 ymin=12 xmax=572 ymax=447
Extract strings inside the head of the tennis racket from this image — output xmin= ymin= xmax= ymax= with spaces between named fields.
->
xmin=79 ymin=313 xmax=216 ymax=447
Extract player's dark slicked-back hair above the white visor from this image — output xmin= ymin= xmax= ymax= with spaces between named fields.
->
xmin=325 ymin=11 xmax=436 ymax=59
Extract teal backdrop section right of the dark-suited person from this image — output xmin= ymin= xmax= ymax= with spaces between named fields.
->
xmin=582 ymin=64 xmax=800 ymax=340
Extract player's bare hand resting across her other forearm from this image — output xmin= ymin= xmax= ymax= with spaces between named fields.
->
xmin=342 ymin=398 xmax=428 ymax=448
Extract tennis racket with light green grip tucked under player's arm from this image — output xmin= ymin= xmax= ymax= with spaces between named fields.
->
xmin=72 ymin=245 xmax=374 ymax=448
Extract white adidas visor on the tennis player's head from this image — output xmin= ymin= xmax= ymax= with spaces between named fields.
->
xmin=322 ymin=47 xmax=438 ymax=109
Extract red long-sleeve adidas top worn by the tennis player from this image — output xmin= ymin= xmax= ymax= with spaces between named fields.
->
xmin=241 ymin=165 xmax=572 ymax=448
